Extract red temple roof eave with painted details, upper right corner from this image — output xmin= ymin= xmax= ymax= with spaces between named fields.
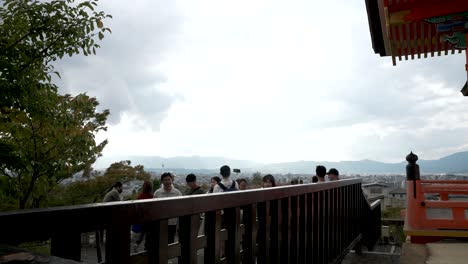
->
xmin=366 ymin=0 xmax=468 ymax=65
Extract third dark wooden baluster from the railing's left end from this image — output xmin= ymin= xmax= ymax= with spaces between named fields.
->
xmin=147 ymin=220 xmax=168 ymax=264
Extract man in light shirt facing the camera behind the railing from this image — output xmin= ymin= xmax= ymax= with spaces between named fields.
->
xmin=154 ymin=172 xmax=182 ymax=244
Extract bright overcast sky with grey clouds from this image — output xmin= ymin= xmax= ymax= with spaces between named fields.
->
xmin=56 ymin=0 xmax=468 ymax=163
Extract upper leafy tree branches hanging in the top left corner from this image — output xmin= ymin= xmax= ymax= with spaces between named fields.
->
xmin=0 ymin=0 xmax=111 ymax=110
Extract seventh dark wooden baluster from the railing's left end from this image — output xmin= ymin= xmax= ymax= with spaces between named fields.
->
xmin=242 ymin=204 xmax=257 ymax=264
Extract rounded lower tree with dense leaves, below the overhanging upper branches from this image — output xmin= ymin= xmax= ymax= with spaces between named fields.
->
xmin=0 ymin=90 xmax=109 ymax=209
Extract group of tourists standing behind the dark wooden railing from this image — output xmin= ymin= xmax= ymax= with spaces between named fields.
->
xmin=103 ymin=165 xmax=339 ymax=251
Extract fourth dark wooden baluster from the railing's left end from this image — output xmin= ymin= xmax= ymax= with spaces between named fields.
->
xmin=179 ymin=214 xmax=200 ymax=264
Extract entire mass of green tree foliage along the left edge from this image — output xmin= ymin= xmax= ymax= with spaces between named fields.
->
xmin=0 ymin=0 xmax=110 ymax=210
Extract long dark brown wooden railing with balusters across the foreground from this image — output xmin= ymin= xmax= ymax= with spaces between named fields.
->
xmin=0 ymin=179 xmax=380 ymax=263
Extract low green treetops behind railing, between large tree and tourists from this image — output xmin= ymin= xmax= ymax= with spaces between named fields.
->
xmin=49 ymin=160 xmax=150 ymax=206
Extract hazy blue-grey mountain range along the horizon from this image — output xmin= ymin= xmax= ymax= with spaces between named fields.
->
xmin=94 ymin=151 xmax=468 ymax=174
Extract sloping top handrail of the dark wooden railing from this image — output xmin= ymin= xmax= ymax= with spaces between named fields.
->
xmin=0 ymin=178 xmax=362 ymax=242
